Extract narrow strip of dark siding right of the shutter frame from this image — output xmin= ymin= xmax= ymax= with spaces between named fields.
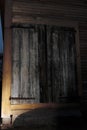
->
xmin=79 ymin=23 xmax=87 ymax=103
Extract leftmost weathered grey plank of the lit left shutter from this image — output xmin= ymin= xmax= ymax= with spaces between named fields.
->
xmin=11 ymin=28 xmax=20 ymax=104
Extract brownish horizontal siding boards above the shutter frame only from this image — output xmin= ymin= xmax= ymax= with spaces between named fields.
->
xmin=13 ymin=0 xmax=87 ymax=21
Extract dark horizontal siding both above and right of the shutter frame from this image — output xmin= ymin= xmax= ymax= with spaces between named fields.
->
xmin=12 ymin=0 xmax=87 ymax=102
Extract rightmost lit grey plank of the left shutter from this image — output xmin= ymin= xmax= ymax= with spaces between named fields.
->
xmin=29 ymin=29 xmax=40 ymax=103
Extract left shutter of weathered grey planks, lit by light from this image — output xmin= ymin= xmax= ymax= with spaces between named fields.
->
xmin=11 ymin=27 xmax=40 ymax=104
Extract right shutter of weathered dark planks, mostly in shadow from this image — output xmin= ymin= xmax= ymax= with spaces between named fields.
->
xmin=47 ymin=26 xmax=77 ymax=102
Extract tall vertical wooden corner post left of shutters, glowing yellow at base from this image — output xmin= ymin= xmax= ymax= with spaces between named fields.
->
xmin=1 ymin=0 xmax=12 ymax=118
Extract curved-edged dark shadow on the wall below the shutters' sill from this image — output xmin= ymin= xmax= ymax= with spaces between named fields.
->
xmin=13 ymin=105 xmax=85 ymax=129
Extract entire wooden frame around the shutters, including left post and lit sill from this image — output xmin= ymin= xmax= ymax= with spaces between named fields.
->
xmin=1 ymin=0 xmax=82 ymax=123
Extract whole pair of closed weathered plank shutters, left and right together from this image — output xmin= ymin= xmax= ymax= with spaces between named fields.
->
xmin=11 ymin=25 xmax=77 ymax=104
